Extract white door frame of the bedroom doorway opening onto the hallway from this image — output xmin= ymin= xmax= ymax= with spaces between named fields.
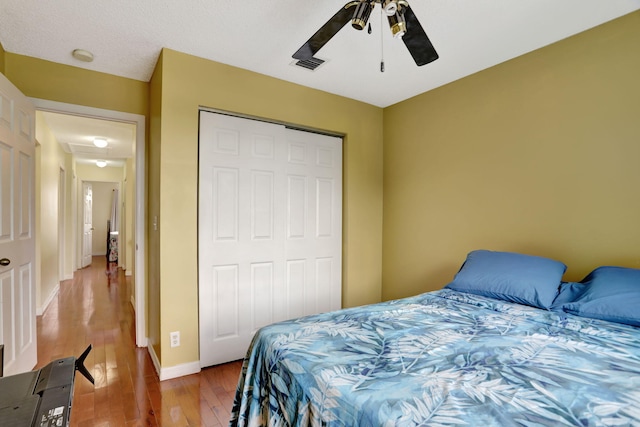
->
xmin=29 ymin=98 xmax=147 ymax=347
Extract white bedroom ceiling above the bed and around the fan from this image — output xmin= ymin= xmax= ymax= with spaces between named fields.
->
xmin=0 ymin=0 xmax=640 ymax=166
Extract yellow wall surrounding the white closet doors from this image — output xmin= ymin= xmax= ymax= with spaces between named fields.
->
xmin=150 ymin=49 xmax=382 ymax=366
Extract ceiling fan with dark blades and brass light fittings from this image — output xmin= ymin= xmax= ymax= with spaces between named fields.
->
xmin=293 ymin=0 xmax=438 ymax=71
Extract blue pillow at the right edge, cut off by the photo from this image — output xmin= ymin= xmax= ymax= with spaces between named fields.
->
xmin=562 ymin=267 xmax=640 ymax=326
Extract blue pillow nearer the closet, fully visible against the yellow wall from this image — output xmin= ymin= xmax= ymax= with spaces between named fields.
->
xmin=446 ymin=250 xmax=567 ymax=308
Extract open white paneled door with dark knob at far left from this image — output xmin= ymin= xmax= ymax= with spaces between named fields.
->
xmin=0 ymin=74 xmax=38 ymax=375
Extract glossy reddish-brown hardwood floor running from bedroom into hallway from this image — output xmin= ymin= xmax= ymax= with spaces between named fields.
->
xmin=37 ymin=257 xmax=241 ymax=427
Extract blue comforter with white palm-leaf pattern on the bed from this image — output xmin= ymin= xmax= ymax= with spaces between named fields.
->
xmin=230 ymin=289 xmax=640 ymax=427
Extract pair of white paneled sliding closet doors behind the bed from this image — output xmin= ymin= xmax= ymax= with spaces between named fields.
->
xmin=198 ymin=111 xmax=342 ymax=367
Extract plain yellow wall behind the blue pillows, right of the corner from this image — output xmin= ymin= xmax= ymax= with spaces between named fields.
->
xmin=383 ymin=12 xmax=640 ymax=299
